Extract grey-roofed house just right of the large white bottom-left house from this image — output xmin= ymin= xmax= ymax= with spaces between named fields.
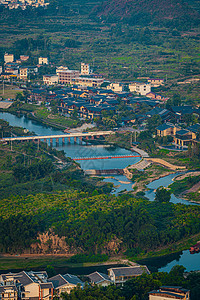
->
xmin=48 ymin=274 xmax=84 ymax=297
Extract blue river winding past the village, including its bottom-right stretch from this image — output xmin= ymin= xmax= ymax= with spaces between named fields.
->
xmin=0 ymin=112 xmax=200 ymax=271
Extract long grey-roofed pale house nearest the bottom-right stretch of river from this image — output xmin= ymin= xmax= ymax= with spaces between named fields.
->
xmin=108 ymin=266 xmax=150 ymax=285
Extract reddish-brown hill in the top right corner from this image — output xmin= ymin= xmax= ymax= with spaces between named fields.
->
xmin=93 ymin=0 xmax=200 ymax=25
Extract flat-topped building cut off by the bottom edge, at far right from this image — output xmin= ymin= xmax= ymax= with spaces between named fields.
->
xmin=149 ymin=286 xmax=190 ymax=300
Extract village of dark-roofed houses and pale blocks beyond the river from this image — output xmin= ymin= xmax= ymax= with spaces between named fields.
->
xmin=0 ymin=53 xmax=200 ymax=150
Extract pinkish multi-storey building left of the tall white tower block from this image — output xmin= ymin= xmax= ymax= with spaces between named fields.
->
xmin=56 ymin=67 xmax=79 ymax=84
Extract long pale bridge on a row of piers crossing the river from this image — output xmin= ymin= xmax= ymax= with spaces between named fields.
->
xmin=0 ymin=131 xmax=113 ymax=143
